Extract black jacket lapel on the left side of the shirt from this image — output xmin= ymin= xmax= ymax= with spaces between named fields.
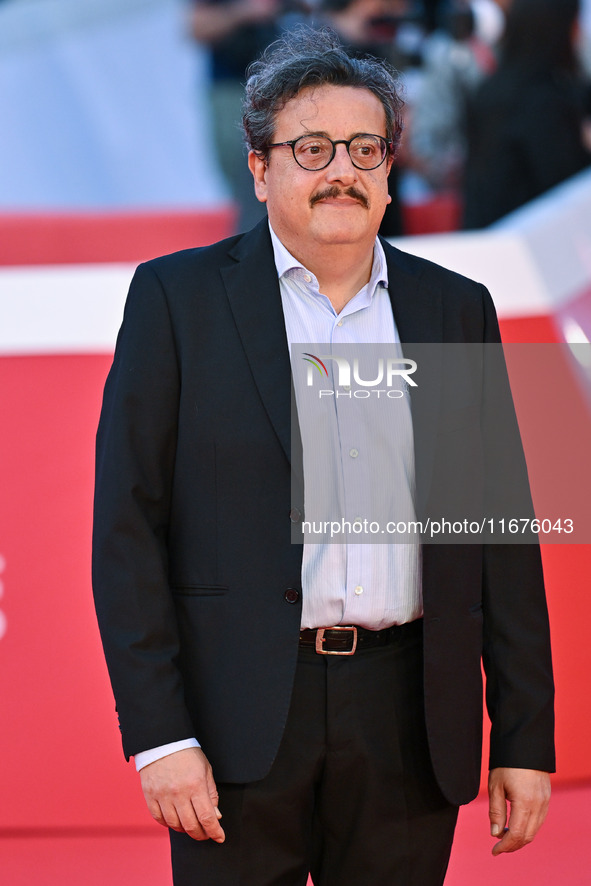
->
xmin=220 ymin=219 xmax=291 ymax=472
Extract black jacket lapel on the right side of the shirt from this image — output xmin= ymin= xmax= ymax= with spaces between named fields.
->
xmin=384 ymin=242 xmax=443 ymax=517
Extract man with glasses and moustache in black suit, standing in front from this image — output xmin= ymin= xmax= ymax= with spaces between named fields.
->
xmin=94 ymin=31 xmax=554 ymax=886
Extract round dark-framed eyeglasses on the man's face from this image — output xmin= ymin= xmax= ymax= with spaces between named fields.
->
xmin=267 ymin=132 xmax=393 ymax=172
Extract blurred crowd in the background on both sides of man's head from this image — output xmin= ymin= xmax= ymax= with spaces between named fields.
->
xmin=191 ymin=0 xmax=591 ymax=235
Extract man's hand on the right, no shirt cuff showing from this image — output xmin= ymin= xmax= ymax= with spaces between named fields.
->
xmin=488 ymin=768 xmax=550 ymax=855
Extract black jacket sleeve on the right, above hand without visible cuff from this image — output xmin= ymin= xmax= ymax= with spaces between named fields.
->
xmin=482 ymin=291 xmax=555 ymax=772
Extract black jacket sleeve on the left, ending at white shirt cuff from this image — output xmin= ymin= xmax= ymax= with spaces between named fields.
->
xmin=93 ymin=265 xmax=194 ymax=757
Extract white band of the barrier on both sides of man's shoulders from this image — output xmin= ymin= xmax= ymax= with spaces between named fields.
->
xmin=0 ymin=172 xmax=591 ymax=354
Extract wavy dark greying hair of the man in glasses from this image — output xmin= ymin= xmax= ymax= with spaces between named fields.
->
xmin=242 ymin=26 xmax=404 ymax=158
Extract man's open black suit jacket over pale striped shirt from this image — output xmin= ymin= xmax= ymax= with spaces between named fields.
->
xmin=93 ymin=222 xmax=554 ymax=803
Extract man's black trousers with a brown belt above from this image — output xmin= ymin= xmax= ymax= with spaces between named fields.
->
xmin=171 ymin=622 xmax=458 ymax=886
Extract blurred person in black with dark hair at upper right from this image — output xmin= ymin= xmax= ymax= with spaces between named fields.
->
xmin=464 ymin=0 xmax=591 ymax=228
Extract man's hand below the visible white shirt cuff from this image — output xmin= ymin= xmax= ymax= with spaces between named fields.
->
xmin=140 ymin=748 xmax=226 ymax=843
